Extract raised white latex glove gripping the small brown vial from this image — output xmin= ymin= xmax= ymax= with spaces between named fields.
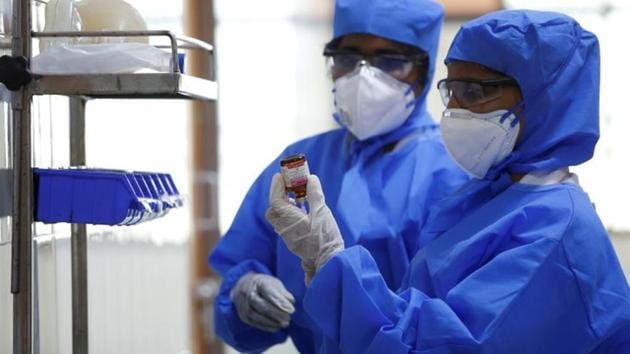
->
xmin=266 ymin=173 xmax=344 ymax=284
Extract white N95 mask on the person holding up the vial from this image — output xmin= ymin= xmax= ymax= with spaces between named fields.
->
xmin=440 ymin=109 xmax=520 ymax=179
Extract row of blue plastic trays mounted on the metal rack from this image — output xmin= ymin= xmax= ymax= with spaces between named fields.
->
xmin=33 ymin=168 xmax=183 ymax=225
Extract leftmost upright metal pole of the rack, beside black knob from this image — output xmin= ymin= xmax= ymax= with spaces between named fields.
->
xmin=11 ymin=0 xmax=33 ymax=354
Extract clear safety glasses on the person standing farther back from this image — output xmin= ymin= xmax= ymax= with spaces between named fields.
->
xmin=324 ymin=49 xmax=426 ymax=80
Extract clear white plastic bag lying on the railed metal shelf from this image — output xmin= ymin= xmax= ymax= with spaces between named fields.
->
xmin=31 ymin=43 xmax=172 ymax=74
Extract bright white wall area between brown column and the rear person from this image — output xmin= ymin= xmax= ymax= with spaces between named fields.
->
xmin=216 ymin=0 xmax=336 ymax=231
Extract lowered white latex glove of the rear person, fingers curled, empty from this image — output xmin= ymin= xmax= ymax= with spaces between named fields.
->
xmin=230 ymin=272 xmax=295 ymax=332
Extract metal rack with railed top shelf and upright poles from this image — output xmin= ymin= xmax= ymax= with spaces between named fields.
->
xmin=6 ymin=0 xmax=218 ymax=354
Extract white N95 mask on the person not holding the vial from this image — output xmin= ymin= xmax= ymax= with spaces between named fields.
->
xmin=333 ymin=65 xmax=415 ymax=140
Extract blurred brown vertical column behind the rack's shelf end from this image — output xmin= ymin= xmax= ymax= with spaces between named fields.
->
xmin=184 ymin=0 xmax=224 ymax=354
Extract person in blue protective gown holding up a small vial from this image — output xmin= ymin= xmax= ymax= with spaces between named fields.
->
xmin=267 ymin=10 xmax=630 ymax=354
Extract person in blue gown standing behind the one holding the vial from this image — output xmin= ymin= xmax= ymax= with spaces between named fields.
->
xmin=209 ymin=0 xmax=469 ymax=353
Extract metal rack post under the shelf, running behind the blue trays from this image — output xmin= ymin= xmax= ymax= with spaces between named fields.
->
xmin=70 ymin=96 xmax=88 ymax=354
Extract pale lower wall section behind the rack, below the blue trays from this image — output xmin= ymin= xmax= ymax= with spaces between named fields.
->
xmin=37 ymin=229 xmax=190 ymax=354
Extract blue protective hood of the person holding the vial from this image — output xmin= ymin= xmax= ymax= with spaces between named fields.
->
xmin=446 ymin=10 xmax=599 ymax=173
